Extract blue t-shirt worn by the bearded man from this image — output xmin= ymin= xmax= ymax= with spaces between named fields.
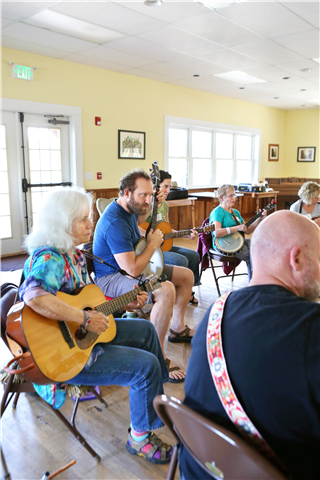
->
xmin=93 ymin=200 xmax=140 ymax=277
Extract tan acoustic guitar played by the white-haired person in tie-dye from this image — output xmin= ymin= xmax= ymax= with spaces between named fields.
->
xmin=7 ymin=278 xmax=164 ymax=385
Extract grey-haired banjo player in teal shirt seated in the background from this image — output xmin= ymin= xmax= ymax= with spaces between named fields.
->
xmin=209 ymin=185 xmax=267 ymax=281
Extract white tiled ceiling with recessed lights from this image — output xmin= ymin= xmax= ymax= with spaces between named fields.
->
xmin=0 ymin=0 xmax=320 ymax=110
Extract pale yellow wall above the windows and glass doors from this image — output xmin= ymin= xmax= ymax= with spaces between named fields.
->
xmin=1 ymin=48 xmax=320 ymax=188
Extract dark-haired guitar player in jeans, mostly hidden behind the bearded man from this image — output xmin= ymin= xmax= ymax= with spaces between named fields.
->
xmin=139 ymin=170 xmax=201 ymax=305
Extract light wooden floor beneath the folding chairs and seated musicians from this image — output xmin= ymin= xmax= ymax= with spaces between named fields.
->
xmin=0 ymin=239 xmax=248 ymax=480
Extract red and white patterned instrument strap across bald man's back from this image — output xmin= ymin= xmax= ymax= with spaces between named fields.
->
xmin=207 ymin=292 xmax=286 ymax=471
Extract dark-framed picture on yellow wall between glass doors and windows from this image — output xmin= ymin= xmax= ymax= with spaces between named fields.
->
xmin=118 ymin=130 xmax=146 ymax=160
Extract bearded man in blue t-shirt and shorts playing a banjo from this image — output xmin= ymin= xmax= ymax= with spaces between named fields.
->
xmin=93 ymin=169 xmax=194 ymax=383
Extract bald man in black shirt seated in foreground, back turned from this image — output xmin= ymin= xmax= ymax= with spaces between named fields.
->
xmin=179 ymin=210 xmax=320 ymax=480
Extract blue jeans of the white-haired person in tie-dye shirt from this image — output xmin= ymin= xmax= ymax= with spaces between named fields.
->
xmin=67 ymin=319 xmax=169 ymax=432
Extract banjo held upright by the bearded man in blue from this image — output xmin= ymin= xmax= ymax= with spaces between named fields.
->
xmin=134 ymin=162 xmax=164 ymax=277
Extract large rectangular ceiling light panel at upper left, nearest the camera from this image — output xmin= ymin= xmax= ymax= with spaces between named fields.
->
xmin=23 ymin=10 xmax=125 ymax=44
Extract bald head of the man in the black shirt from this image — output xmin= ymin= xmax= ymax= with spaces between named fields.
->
xmin=251 ymin=210 xmax=320 ymax=298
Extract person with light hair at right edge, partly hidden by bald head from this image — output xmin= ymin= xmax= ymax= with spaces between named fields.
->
xmin=290 ymin=182 xmax=320 ymax=227
